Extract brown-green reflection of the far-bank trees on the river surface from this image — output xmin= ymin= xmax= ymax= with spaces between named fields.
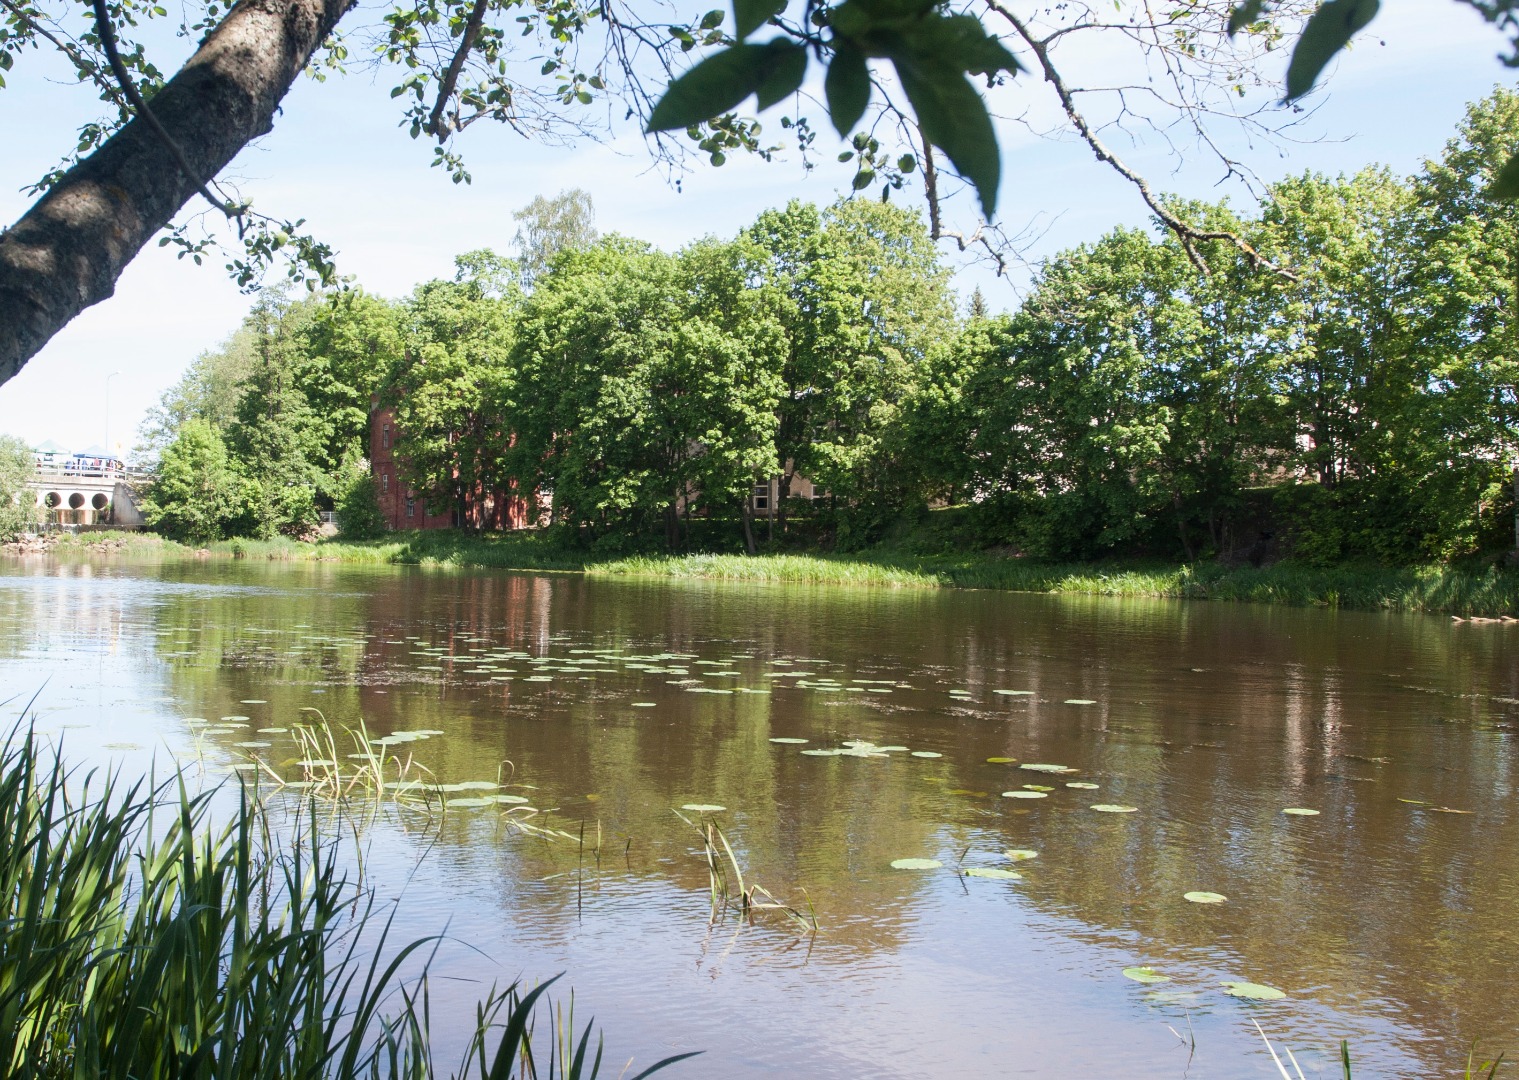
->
xmin=121 ymin=571 xmax=1519 ymax=1060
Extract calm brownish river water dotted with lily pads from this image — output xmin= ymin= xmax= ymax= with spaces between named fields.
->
xmin=0 ymin=559 xmax=1519 ymax=1078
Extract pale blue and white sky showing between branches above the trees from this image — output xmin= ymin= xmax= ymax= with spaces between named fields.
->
xmin=0 ymin=0 xmax=1514 ymax=450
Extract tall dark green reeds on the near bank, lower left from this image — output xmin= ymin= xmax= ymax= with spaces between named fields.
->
xmin=0 ymin=732 xmax=695 ymax=1080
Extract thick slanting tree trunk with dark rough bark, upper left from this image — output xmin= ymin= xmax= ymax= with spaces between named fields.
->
xmin=0 ymin=0 xmax=351 ymax=383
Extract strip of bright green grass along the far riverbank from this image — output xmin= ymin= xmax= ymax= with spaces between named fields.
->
xmin=14 ymin=530 xmax=1519 ymax=618
